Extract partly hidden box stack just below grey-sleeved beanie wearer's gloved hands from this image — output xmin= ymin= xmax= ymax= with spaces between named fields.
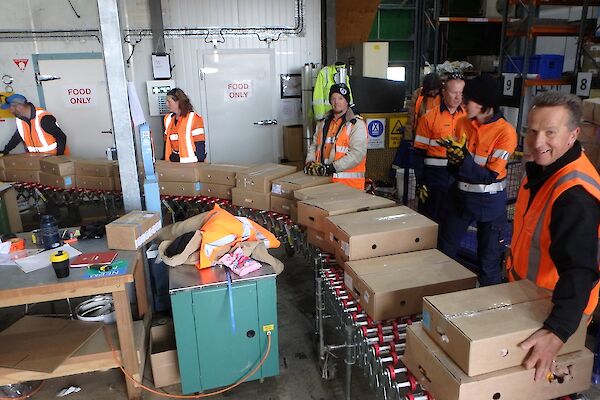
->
xmin=271 ymin=171 xmax=331 ymax=221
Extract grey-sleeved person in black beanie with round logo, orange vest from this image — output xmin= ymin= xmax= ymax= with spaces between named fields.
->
xmin=304 ymin=83 xmax=367 ymax=190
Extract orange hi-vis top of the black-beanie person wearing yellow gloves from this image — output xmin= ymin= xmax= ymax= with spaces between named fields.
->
xmin=456 ymin=116 xmax=517 ymax=181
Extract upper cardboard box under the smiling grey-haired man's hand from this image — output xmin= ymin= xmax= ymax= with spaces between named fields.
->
xmin=423 ymin=280 xmax=587 ymax=376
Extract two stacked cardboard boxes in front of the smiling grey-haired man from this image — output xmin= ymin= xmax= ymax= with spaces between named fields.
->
xmin=403 ymin=280 xmax=594 ymax=400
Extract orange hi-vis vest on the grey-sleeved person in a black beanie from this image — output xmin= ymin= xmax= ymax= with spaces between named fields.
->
xmin=315 ymin=118 xmax=367 ymax=190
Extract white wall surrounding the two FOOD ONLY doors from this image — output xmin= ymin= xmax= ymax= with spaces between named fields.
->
xmin=0 ymin=0 xmax=321 ymax=161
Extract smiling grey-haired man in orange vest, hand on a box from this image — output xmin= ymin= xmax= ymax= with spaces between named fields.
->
xmin=507 ymin=92 xmax=600 ymax=380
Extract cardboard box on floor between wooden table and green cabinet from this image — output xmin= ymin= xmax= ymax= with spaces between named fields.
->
xmin=150 ymin=323 xmax=181 ymax=388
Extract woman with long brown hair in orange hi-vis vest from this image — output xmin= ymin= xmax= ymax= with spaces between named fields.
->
xmin=164 ymin=88 xmax=206 ymax=163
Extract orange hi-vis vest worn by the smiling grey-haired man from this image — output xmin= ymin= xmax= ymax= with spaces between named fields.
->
xmin=507 ymin=153 xmax=600 ymax=315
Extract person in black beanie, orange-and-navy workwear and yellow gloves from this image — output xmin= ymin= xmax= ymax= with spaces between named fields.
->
xmin=438 ymin=75 xmax=517 ymax=286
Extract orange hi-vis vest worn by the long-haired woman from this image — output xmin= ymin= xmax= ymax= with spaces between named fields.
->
xmin=165 ymin=111 xmax=205 ymax=163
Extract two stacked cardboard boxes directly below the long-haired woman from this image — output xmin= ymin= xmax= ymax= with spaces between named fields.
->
xmin=155 ymin=160 xmax=203 ymax=196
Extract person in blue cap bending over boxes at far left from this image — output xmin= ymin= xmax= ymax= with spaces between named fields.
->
xmin=0 ymin=93 xmax=69 ymax=156
